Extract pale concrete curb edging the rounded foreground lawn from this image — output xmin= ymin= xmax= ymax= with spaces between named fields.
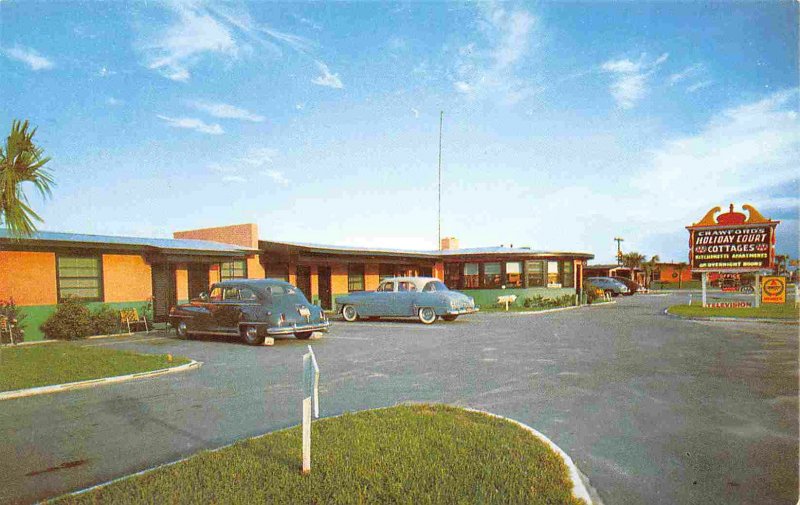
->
xmin=54 ymin=402 xmax=592 ymax=505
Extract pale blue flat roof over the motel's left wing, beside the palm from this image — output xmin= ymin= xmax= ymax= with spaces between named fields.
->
xmin=0 ymin=228 xmax=258 ymax=255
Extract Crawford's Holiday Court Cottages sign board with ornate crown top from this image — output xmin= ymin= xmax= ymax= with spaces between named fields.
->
xmin=686 ymin=204 xmax=780 ymax=272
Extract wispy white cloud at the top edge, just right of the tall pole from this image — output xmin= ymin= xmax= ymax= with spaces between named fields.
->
xmin=453 ymin=3 xmax=537 ymax=104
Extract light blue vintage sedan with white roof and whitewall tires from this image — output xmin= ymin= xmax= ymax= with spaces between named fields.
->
xmin=336 ymin=277 xmax=479 ymax=324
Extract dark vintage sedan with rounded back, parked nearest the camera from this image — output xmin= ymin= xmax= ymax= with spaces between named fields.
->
xmin=169 ymin=279 xmax=330 ymax=345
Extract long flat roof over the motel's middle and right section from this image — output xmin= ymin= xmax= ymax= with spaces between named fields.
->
xmin=259 ymin=240 xmax=594 ymax=259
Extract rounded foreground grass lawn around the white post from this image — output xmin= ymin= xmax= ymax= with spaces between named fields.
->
xmin=56 ymin=405 xmax=584 ymax=504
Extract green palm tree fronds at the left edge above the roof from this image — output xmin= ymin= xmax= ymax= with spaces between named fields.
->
xmin=0 ymin=120 xmax=55 ymax=236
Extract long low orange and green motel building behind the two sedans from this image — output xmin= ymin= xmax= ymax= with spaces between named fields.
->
xmin=0 ymin=224 xmax=594 ymax=340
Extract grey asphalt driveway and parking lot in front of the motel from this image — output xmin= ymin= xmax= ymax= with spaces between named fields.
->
xmin=0 ymin=295 xmax=798 ymax=504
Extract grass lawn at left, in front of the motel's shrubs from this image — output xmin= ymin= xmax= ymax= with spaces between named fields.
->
xmin=0 ymin=343 xmax=190 ymax=391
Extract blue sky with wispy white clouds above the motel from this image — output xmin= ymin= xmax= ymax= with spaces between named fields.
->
xmin=0 ymin=0 xmax=800 ymax=262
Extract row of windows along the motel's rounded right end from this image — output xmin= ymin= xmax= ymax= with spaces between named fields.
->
xmin=444 ymin=260 xmax=575 ymax=289
